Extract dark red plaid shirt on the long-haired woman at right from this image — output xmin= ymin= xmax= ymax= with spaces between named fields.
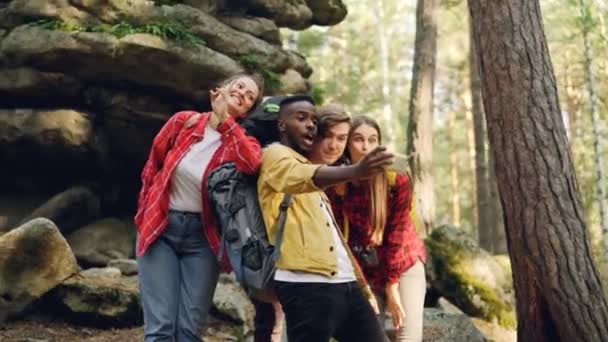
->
xmin=326 ymin=174 xmax=426 ymax=290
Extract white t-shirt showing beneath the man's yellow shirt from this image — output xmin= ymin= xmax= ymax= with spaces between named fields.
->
xmin=274 ymin=196 xmax=357 ymax=283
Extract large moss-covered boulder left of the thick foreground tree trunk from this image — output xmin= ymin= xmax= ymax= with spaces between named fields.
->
xmin=426 ymin=226 xmax=516 ymax=327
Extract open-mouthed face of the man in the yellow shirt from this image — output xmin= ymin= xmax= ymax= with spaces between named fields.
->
xmin=279 ymin=101 xmax=317 ymax=156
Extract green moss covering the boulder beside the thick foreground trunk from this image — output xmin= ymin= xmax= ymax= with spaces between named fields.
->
xmin=426 ymin=224 xmax=517 ymax=328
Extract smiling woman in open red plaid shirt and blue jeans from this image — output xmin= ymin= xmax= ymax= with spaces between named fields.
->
xmin=135 ymin=74 xmax=263 ymax=342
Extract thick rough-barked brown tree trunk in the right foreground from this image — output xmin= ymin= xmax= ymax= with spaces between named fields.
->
xmin=469 ymin=0 xmax=608 ymax=342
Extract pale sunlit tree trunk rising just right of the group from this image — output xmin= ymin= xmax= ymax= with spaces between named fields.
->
xmin=407 ymin=0 xmax=439 ymax=234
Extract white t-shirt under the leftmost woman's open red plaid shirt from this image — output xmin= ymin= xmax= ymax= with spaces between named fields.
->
xmin=169 ymin=126 xmax=221 ymax=212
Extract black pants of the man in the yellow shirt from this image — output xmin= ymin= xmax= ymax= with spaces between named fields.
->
xmin=275 ymin=281 xmax=388 ymax=342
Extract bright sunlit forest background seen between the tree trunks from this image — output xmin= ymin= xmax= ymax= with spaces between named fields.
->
xmin=283 ymin=0 xmax=608 ymax=264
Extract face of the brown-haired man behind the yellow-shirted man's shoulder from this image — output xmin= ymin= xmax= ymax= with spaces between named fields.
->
xmin=310 ymin=122 xmax=350 ymax=165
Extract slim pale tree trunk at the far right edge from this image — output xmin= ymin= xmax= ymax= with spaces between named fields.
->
xmin=579 ymin=0 xmax=608 ymax=262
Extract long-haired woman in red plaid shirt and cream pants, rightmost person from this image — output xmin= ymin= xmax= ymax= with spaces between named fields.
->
xmin=327 ymin=116 xmax=426 ymax=341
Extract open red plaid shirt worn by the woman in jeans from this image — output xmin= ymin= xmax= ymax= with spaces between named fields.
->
xmin=135 ymin=111 xmax=262 ymax=269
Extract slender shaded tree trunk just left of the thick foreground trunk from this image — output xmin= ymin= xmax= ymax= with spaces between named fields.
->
xmin=469 ymin=23 xmax=492 ymax=252
